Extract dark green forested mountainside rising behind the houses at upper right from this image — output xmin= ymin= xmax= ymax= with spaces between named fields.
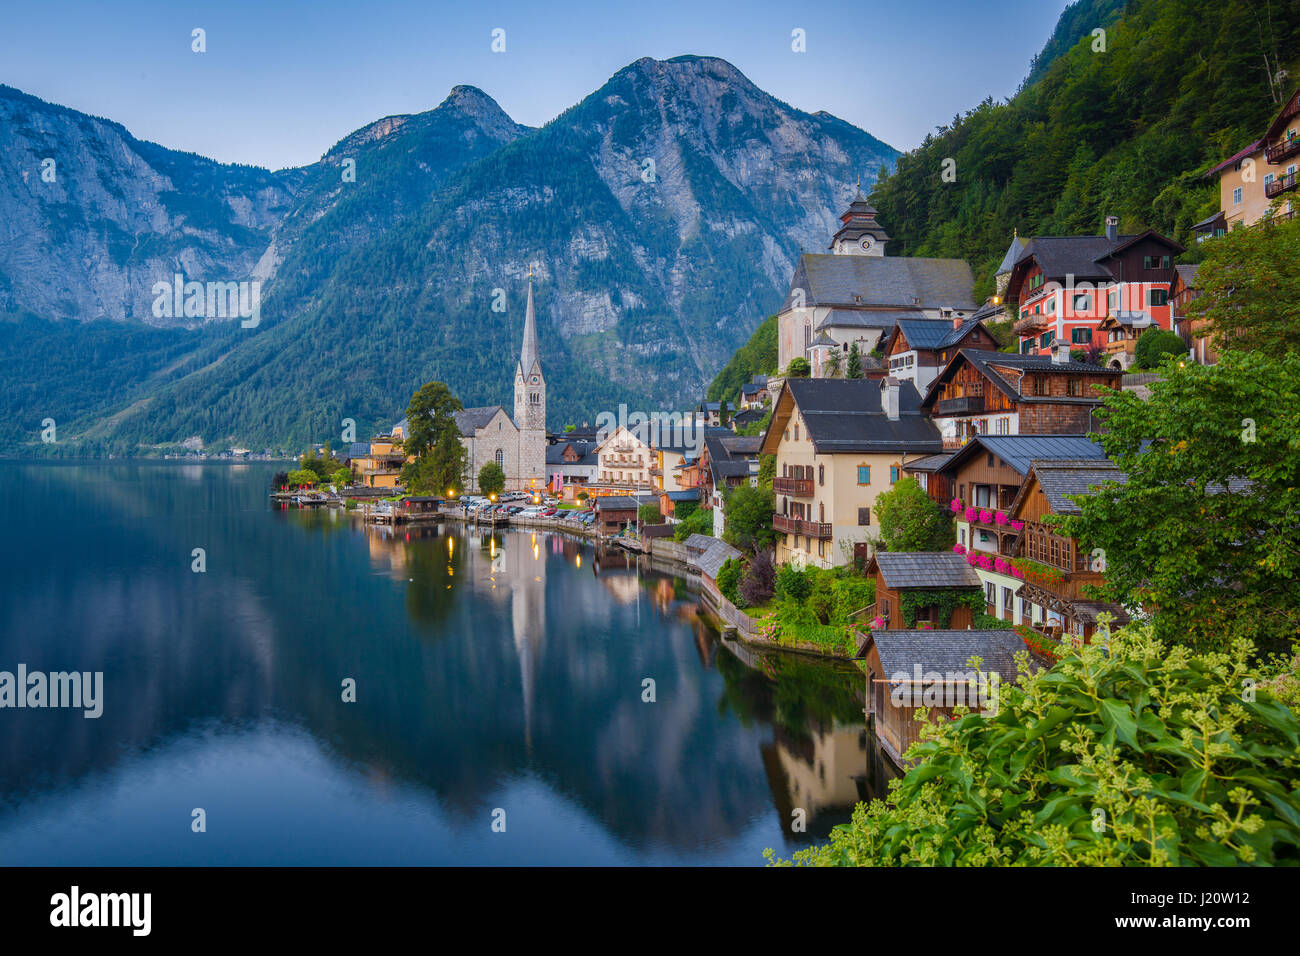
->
xmin=871 ymin=0 xmax=1300 ymax=295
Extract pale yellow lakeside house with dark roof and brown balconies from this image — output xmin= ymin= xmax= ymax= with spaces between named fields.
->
xmin=762 ymin=377 xmax=944 ymax=568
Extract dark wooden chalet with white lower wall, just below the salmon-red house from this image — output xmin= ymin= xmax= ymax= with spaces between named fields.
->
xmin=920 ymin=343 xmax=1123 ymax=449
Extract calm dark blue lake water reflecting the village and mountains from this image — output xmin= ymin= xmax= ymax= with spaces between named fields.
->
xmin=0 ymin=462 xmax=885 ymax=865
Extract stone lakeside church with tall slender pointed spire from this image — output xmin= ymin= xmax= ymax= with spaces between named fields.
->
xmin=455 ymin=273 xmax=546 ymax=493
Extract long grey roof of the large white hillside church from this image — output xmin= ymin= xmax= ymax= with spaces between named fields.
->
xmin=781 ymin=252 xmax=975 ymax=312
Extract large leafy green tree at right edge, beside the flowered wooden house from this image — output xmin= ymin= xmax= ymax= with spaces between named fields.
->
xmin=1061 ymin=351 xmax=1300 ymax=658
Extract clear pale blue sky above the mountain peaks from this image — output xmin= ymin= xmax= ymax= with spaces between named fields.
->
xmin=0 ymin=0 xmax=1066 ymax=169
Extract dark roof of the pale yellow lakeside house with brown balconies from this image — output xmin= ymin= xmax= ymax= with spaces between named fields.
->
xmin=785 ymin=378 xmax=944 ymax=454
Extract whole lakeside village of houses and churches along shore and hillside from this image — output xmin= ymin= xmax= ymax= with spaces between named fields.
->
xmin=273 ymin=94 xmax=1300 ymax=766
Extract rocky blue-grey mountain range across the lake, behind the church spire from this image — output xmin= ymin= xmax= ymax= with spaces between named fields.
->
xmin=0 ymin=56 xmax=898 ymax=454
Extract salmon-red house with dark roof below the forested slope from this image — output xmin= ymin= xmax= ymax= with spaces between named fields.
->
xmin=1006 ymin=216 xmax=1187 ymax=360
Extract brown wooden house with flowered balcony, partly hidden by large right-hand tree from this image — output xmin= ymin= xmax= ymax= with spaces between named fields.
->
xmin=1008 ymin=458 xmax=1128 ymax=643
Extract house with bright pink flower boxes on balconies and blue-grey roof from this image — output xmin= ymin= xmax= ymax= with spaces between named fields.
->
xmin=939 ymin=434 xmax=1109 ymax=623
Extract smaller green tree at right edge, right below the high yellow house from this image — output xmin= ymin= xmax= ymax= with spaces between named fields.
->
xmin=1188 ymin=220 xmax=1300 ymax=352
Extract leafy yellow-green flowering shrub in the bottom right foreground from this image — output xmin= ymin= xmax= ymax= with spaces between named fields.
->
xmin=764 ymin=626 xmax=1300 ymax=866
